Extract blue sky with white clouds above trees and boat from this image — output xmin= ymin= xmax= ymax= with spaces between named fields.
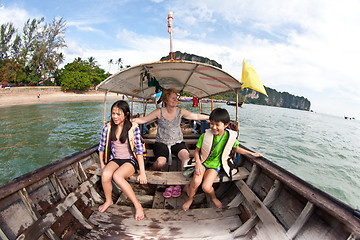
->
xmin=0 ymin=0 xmax=360 ymax=119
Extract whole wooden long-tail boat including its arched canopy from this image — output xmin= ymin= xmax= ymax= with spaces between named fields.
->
xmin=0 ymin=11 xmax=360 ymax=240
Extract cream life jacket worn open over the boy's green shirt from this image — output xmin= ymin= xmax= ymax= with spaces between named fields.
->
xmin=200 ymin=129 xmax=238 ymax=178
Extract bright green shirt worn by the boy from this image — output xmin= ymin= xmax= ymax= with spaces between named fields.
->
xmin=196 ymin=131 xmax=240 ymax=169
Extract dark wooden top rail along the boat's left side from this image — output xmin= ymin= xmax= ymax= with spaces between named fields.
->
xmin=0 ymin=144 xmax=99 ymax=200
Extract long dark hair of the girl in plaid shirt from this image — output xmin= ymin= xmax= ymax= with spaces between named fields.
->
xmin=109 ymin=100 xmax=132 ymax=145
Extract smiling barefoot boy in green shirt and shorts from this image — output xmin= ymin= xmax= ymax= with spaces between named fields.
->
xmin=182 ymin=108 xmax=262 ymax=211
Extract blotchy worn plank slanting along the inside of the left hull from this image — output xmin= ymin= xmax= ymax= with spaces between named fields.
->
xmin=18 ymin=175 xmax=99 ymax=240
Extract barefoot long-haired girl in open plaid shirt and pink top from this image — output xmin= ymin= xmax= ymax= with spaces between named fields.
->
xmin=98 ymin=100 xmax=147 ymax=220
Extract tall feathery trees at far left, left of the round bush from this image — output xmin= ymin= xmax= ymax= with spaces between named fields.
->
xmin=0 ymin=18 xmax=66 ymax=85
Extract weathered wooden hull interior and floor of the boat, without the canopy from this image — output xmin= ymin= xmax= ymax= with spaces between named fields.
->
xmin=0 ymin=143 xmax=360 ymax=240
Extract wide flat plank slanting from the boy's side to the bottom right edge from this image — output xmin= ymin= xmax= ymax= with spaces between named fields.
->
xmin=235 ymin=180 xmax=289 ymax=240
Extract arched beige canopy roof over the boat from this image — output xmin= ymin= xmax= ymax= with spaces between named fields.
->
xmin=96 ymin=60 xmax=242 ymax=99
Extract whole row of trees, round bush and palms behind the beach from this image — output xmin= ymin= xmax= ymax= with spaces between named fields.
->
xmin=0 ymin=18 xmax=119 ymax=90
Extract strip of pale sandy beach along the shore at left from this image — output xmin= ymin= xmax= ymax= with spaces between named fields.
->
xmin=0 ymin=88 xmax=126 ymax=107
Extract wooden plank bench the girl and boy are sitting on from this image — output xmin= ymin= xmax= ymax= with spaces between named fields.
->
xmin=86 ymin=163 xmax=249 ymax=185
